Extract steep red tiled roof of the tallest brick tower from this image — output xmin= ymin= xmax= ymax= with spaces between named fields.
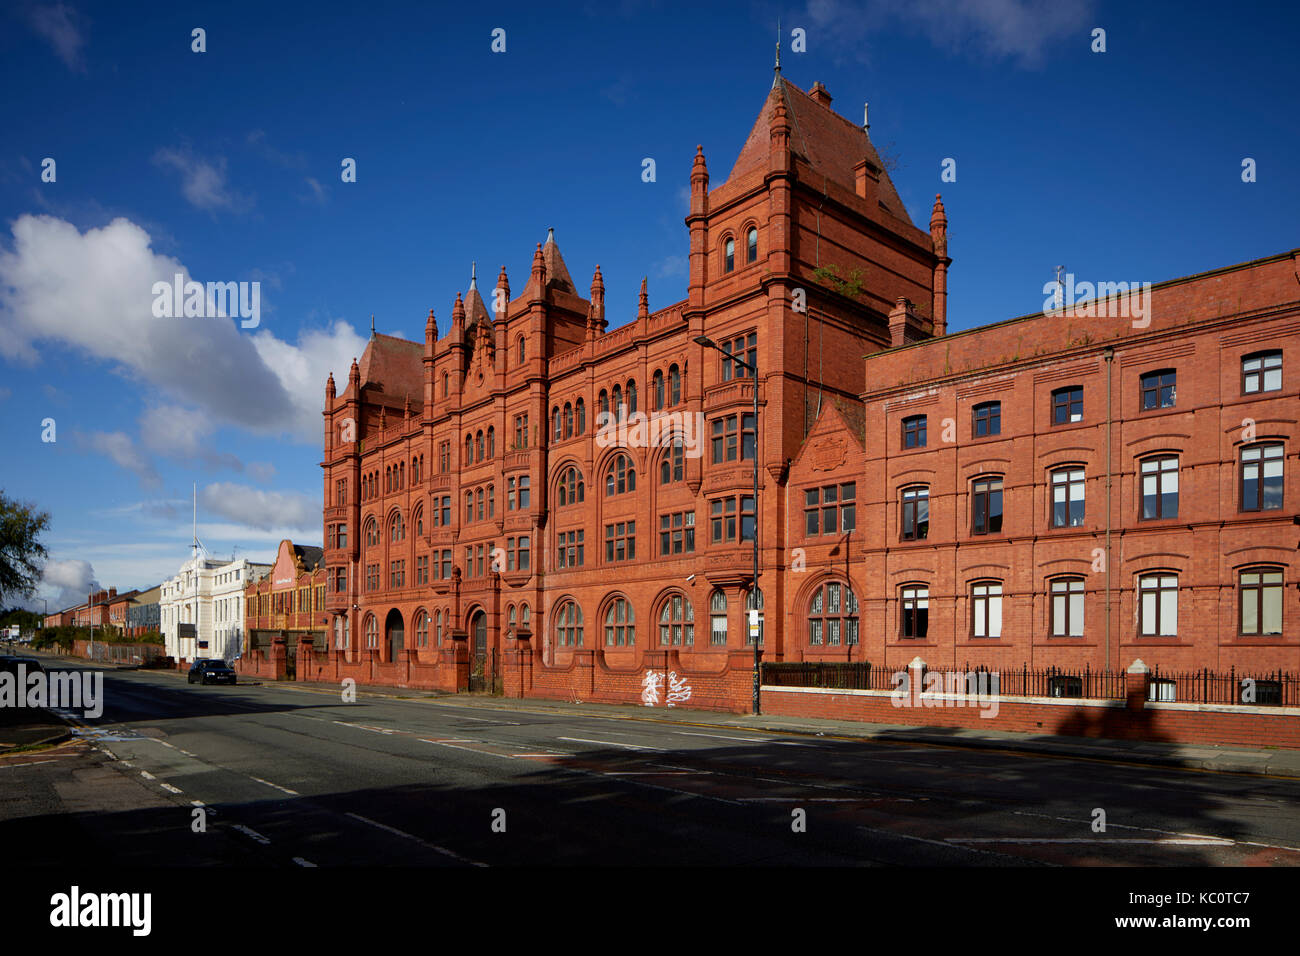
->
xmin=727 ymin=77 xmax=915 ymax=225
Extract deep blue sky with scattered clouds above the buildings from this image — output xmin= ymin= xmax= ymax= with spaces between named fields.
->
xmin=0 ymin=0 xmax=1300 ymax=607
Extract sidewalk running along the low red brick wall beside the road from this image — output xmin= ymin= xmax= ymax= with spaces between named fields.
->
xmin=268 ymin=682 xmax=1300 ymax=779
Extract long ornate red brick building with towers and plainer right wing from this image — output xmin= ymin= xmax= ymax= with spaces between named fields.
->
xmin=314 ymin=75 xmax=1300 ymax=709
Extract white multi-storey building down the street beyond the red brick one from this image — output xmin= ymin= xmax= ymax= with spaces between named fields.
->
xmin=159 ymin=557 xmax=270 ymax=661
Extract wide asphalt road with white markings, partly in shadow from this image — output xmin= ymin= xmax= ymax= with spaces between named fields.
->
xmin=0 ymin=660 xmax=1300 ymax=868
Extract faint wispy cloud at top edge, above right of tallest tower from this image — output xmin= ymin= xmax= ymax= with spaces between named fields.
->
xmin=807 ymin=0 xmax=1093 ymax=66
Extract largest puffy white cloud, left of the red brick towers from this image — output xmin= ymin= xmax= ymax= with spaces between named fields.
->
xmin=0 ymin=215 xmax=365 ymax=447
